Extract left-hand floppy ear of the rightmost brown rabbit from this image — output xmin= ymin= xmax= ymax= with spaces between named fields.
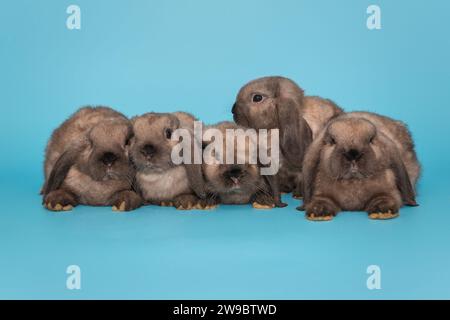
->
xmin=302 ymin=132 xmax=325 ymax=206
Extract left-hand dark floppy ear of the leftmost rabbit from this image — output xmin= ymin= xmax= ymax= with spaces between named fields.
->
xmin=42 ymin=149 xmax=79 ymax=196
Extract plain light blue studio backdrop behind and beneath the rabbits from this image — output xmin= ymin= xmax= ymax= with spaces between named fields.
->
xmin=0 ymin=0 xmax=450 ymax=299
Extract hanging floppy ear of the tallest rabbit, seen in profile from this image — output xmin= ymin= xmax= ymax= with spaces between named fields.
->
xmin=276 ymin=99 xmax=312 ymax=169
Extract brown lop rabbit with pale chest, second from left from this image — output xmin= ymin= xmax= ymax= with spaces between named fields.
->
xmin=130 ymin=112 xmax=208 ymax=209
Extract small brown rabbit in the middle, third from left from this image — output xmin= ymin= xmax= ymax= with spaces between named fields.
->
xmin=202 ymin=122 xmax=286 ymax=209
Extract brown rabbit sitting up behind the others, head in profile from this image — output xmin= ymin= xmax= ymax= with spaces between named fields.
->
xmin=232 ymin=77 xmax=342 ymax=197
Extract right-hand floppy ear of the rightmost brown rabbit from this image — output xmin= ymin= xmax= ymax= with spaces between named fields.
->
xmin=391 ymin=150 xmax=418 ymax=207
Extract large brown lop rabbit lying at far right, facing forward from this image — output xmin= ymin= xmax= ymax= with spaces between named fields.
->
xmin=299 ymin=112 xmax=420 ymax=220
